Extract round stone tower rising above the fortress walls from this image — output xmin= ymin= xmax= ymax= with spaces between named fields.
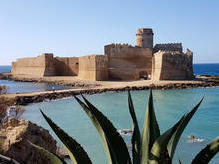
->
xmin=136 ymin=28 xmax=154 ymax=50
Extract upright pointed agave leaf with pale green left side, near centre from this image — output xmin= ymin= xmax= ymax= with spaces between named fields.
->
xmin=141 ymin=90 xmax=160 ymax=164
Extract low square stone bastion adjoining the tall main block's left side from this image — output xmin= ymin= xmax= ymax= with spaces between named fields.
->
xmin=78 ymin=55 xmax=108 ymax=81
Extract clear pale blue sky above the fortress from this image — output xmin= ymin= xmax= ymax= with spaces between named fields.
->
xmin=0 ymin=0 xmax=219 ymax=65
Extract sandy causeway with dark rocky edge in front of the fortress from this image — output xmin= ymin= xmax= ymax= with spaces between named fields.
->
xmin=0 ymin=75 xmax=219 ymax=105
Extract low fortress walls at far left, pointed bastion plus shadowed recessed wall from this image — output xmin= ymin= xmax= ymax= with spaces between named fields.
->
xmin=11 ymin=53 xmax=79 ymax=77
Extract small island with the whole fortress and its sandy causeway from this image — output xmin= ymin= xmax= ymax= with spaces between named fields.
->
xmin=0 ymin=28 xmax=219 ymax=105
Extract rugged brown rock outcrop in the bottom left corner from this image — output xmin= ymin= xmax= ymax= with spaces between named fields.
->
xmin=0 ymin=120 xmax=57 ymax=164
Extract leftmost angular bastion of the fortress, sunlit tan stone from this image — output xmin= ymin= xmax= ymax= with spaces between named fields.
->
xmin=11 ymin=54 xmax=55 ymax=77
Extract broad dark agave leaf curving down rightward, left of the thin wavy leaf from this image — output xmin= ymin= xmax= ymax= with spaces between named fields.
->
xmin=75 ymin=95 xmax=131 ymax=164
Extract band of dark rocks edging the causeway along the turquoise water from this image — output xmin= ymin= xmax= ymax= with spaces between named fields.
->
xmin=15 ymin=82 xmax=219 ymax=105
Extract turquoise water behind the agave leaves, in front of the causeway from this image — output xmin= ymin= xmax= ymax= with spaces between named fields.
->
xmin=23 ymin=87 xmax=219 ymax=164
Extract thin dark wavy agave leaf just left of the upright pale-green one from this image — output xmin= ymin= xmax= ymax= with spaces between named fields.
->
xmin=128 ymin=91 xmax=141 ymax=164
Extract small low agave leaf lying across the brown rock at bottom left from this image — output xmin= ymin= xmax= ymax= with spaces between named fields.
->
xmin=28 ymin=141 xmax=66 ymax=164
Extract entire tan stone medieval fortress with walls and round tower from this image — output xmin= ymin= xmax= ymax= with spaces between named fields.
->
xmin=12 ymin=28 xmax=193 ymax=81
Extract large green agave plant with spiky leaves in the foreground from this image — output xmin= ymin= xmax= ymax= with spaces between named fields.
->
xmin=32 ymin=91 xmax=219 ymax=164
